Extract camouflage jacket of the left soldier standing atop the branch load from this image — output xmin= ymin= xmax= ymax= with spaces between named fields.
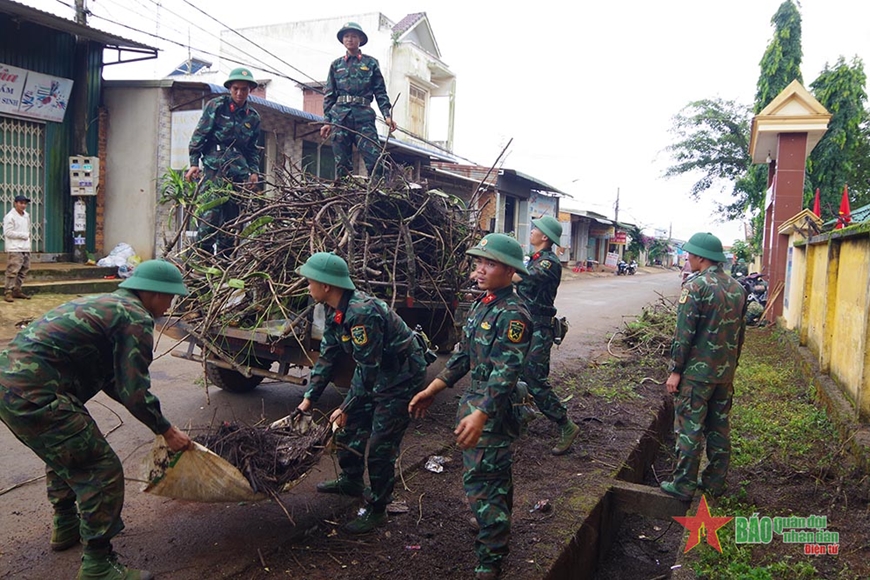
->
xmin=189 ymin=95 xmax=260 ymax=181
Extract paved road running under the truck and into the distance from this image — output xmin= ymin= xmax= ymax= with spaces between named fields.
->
xmin=0 ymin=269 xmax=679 ymax=580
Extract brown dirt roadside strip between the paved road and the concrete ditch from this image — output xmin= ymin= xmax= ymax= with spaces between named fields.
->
xmin=238 ymin=361 xmax=662 ymax=580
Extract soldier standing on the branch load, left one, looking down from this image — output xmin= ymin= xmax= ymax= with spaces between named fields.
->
xmin=185 ymin=68 xmax=260 ymax=252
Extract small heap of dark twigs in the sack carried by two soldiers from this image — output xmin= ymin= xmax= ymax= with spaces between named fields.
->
xmin=195 ymin=421 xmax=331 ymax=494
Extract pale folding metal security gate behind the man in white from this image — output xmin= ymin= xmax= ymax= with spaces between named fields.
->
xmin=0 ymin=116 xmax=45 ymax=252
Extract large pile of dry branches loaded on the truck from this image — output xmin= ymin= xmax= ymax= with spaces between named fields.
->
xmin=164 ymin=156 xmax=479 ymax=348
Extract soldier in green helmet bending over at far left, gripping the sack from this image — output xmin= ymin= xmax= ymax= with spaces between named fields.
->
xmin=0 ymin=260 xmax=191 ymax=580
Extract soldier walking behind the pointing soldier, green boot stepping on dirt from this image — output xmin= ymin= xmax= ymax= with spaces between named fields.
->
xmin=513 ymin=216 xmax=580 ymax=455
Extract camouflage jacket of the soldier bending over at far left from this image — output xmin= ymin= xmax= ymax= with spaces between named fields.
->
xmin=0 ymin=288 xmax=170 ymax=434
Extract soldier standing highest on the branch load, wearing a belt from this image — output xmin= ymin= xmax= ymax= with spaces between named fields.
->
xmin=320 ymin=22 xmax=396 ymax=178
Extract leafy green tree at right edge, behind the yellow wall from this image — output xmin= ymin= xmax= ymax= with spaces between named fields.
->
xmin=805 ymin=56 xmax=868 ymax=220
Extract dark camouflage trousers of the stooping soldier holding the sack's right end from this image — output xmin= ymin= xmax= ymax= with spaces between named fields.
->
xmin=335 ymin=388 xmax=422 ymax=508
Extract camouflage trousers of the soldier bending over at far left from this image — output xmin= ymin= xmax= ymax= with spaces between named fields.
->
xmin=0 ymin=386 xmax=124 ymax=542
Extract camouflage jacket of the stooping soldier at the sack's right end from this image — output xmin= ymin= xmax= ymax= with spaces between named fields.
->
xmin=305 ymin=290 xmax=426 ymax=411
